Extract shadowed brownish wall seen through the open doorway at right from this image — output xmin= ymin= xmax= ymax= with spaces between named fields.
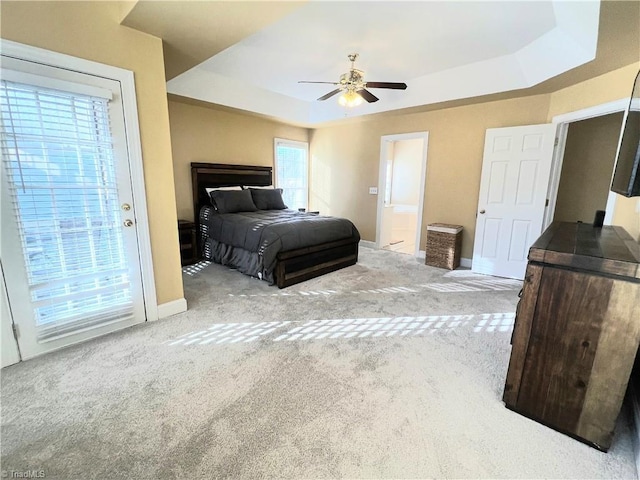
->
xmin=554 ymin=112 xmax=623 ymax=223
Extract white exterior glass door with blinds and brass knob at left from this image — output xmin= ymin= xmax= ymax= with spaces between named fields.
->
xmin=0 ymin=57 xmax=145 ymax=359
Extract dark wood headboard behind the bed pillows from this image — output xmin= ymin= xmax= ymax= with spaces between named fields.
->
xmin=191 ymin=162 xmax=273 ymax=219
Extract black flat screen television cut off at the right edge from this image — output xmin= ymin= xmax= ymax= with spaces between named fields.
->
xmin=611 ymin=72 xmax=640 ymax=197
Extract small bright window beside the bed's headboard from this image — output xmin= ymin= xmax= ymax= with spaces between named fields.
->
xmin=275 ymin=138 xmax=309 ymax=210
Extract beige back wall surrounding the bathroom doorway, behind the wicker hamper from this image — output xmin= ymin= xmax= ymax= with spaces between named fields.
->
xmin=310 ymin=95 xmax=549 ymax=258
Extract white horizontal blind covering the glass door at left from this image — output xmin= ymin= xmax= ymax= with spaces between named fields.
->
xmin=0 ymin=80 xmax=133 ymax=341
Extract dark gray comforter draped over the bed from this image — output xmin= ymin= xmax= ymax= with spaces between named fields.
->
xmin=200 ymin=206 xmax=360 ymax=282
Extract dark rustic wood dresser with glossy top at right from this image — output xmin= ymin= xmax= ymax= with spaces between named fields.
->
xmin=503 ymin=223 xmax=640 ymax=451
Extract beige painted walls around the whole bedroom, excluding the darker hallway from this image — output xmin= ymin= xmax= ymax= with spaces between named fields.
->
xmin=0 ymin=0 xmax=640 ymax=312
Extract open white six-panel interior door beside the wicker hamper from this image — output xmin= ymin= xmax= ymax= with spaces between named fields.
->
xmin=472 ymin=124 xmax=556 ymax=279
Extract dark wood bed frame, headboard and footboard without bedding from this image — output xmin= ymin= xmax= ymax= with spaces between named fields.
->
xmin=191 ymin=163 xmax=359 ymax=288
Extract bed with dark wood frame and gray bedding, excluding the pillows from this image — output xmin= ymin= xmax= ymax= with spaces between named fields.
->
xmin=191 ymin=163 xmax=360 ymax=288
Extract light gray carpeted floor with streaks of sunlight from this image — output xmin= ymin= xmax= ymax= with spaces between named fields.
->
xmin=0 ymin=248 xmax=636 ymax=480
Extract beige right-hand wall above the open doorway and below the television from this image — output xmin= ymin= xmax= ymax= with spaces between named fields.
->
xmin=547 ymin=63 xmax=640 ymax=240
